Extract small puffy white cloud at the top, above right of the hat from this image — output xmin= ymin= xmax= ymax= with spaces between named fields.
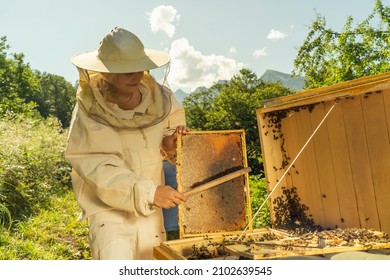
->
xmin=148 ymin=5 xmax=180 ymax=38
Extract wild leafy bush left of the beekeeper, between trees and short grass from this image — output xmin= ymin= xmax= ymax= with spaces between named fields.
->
xmin=0 ymin=114 xmax=71 ymax=224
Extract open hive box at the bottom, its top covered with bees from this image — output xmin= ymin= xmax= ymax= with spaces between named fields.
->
xmin=154 ymin=228 xmax=390 ymax=260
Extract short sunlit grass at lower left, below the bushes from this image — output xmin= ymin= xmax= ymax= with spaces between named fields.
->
xmin=0 ymin=191 xmax=90 ymax=260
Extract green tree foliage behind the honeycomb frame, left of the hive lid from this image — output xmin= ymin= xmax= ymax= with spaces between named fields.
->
xmin=183 ymin=69 xmax=292 ymax=174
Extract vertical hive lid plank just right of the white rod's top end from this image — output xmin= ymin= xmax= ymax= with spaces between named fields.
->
xmin=341 ymin=96 xmax=380 ymax=229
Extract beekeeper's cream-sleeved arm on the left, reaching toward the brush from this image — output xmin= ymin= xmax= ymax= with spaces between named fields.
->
xmin=66 ymin=107 xmax=156 ymax=216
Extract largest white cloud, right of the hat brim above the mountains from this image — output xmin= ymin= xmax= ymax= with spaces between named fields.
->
xmin=168 ymin=38 xmax=245 ymax=90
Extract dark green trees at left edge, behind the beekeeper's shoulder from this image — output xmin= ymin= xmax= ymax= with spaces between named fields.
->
xmin=0 ymin=37 xmax=76 ymax=127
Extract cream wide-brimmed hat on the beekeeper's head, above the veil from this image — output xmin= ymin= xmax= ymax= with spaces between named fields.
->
xmin=71 ymin=28 xmax=170 ymax=73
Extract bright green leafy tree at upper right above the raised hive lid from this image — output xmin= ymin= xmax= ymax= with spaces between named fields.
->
xmin=293 ymin=0 xmax=390 ymax=89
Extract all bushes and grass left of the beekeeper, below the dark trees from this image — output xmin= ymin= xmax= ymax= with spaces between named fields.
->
xmin=0 ymin=112 xmax=89 ymax=259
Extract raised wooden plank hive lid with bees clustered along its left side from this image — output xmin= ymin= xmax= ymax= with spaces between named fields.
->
xmin=257 ymin=73 xmax=390 ymax=233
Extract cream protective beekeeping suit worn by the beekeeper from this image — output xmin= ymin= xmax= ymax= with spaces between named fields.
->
xmin=65 ymin=69 xmax=185 ymax=259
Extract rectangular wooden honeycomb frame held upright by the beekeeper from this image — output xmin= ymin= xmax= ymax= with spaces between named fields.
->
xmin=176 ymin=130 xmax=251 ymax=238
